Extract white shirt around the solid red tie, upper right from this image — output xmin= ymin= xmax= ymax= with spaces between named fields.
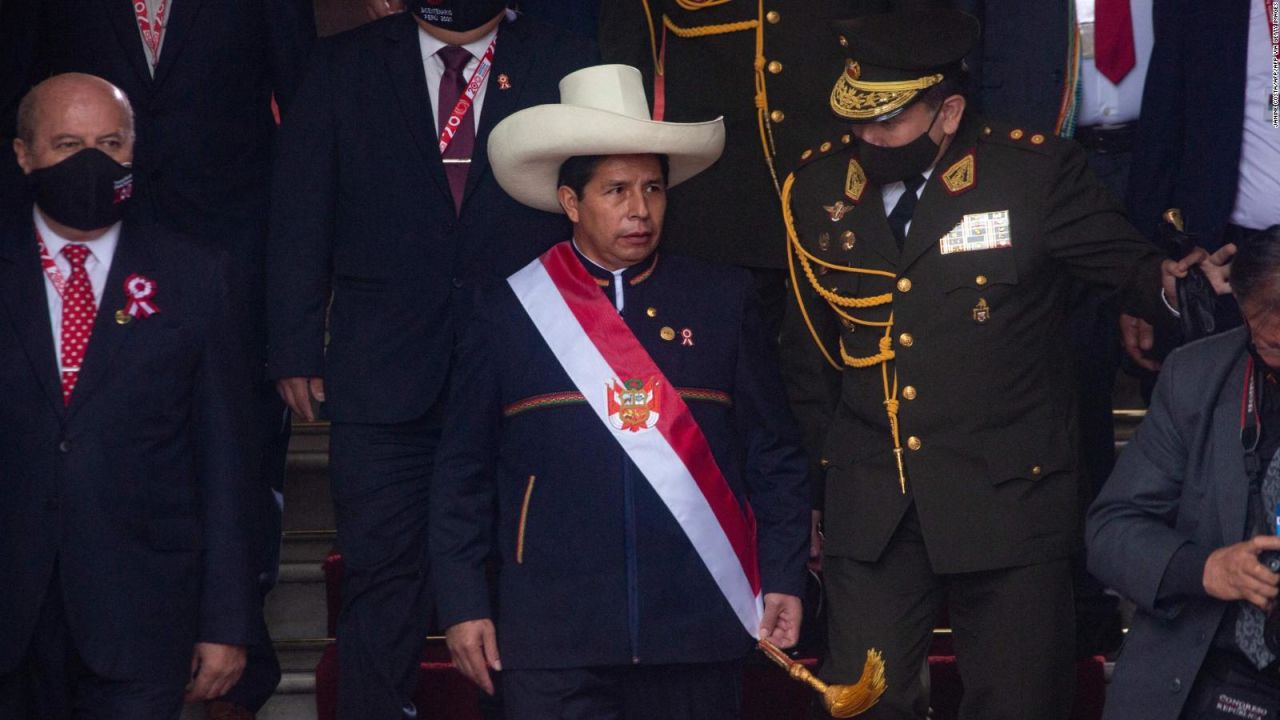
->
xmin=1075 ymin=0 xmax=1156 ymax=127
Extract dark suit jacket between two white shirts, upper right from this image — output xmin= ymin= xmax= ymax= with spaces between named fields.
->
xmin=1128 ymin=0 xmax=1262 ymax=243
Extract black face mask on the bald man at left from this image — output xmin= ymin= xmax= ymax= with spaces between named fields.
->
xmin=27 ymin=147 xmax=133 ymax=231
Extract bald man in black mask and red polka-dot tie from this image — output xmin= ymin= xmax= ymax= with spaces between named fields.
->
xmin=0 ymin=74 xmax=256 ymax=719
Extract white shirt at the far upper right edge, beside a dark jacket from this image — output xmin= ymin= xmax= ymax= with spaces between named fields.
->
xmin=1231 ymin=0 xmax=1280 ymax=229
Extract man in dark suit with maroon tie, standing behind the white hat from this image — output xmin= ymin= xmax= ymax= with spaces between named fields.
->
xmin=268 ymin=0 xmax=595 ymax=717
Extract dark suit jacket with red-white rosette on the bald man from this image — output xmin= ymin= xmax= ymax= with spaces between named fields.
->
xmin=0 ymin=210 xmax=257 ymax=683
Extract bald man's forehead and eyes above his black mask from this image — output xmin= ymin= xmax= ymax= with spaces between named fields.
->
xmin=14 ymin=83 xmax=133 ymax=174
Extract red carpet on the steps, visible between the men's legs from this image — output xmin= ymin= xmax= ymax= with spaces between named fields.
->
xmin=316 ymin=553 xmax=1106 ymax=720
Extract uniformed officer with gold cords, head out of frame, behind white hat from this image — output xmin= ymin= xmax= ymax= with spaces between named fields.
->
xmin=599 ymin=0 xmax=937 ymax=329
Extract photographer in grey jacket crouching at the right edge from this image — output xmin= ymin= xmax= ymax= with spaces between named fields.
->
xmin=1087 ymin=225 xmax=1280 ymax=720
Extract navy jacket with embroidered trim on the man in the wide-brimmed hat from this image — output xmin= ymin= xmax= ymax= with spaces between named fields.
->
xmin=430 ymin=248 xmax=809 ymax=669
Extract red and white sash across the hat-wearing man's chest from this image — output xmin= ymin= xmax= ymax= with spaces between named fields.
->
xmin=507 ymin=242 xmax=763 ymax=638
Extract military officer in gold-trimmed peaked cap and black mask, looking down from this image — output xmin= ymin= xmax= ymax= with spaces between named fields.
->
xmin=782 ymin=9 xmax=1202 ymax=720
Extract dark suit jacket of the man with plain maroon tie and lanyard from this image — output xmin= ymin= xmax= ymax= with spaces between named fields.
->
xmin=268 ymin=14 xmax=596 ymax=423
